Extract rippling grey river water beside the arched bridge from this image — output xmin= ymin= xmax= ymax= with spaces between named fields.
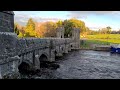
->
xmin=22 ymin=50 xmax=120 ymax=79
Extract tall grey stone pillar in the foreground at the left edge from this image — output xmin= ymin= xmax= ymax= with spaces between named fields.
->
xmin=0 ymin=11 xmax=20 ymax=78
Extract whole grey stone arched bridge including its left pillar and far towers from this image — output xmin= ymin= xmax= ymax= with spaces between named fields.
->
xmin=0 ymin=11 xmax=80 ymax=78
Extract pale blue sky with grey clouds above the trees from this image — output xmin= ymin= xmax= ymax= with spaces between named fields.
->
xmin=14 ymin=11 xmax=120 ymax=30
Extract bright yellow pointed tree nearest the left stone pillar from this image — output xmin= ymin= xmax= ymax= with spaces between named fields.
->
xmin=25 ymin=18 xmax=35 ymax=37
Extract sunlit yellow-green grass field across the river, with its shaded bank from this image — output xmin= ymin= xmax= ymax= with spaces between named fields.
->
xmin=80 ymin=34 xmax=120 ymax=48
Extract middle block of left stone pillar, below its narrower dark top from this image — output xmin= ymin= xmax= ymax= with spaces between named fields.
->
xmin=0 ymin=32 xmax=17 ymax=56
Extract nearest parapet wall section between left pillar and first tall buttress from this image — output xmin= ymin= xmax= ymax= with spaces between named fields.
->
xmin=16 ymin=38 xmax=50 ymax=55
